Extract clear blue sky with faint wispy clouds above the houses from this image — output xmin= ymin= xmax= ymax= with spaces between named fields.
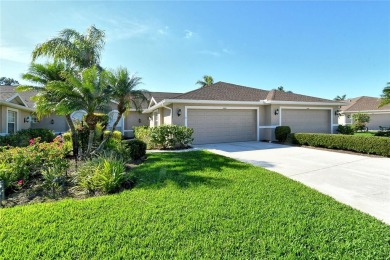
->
xmin=0 ymin=0 xmax=390 ymax=99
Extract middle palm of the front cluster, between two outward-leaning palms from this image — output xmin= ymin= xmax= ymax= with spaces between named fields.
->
xmin=58 ymin=65 xmax=112 ymax=155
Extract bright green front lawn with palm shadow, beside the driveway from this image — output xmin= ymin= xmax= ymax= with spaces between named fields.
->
xmin=0 ymin=151 xmax=390 ymax=259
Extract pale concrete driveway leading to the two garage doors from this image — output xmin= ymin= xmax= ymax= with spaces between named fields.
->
xmin=194 ymin=142 xmax=390 ymax=225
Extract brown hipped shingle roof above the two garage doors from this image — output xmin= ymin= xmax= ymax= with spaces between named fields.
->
xmin=174 ymin=82 xmax=338 ymax=103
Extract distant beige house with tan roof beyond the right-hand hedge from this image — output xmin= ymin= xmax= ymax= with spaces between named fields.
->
xmin=339 ymin=96 xmax=390 ymax=130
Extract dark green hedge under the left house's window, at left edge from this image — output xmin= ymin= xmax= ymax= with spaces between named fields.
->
xmin=0 ymin=128 xmax=54 ymax=147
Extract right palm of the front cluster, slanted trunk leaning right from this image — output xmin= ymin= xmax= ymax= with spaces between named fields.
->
xmin=95 ymin=67 xmax=147 ymax=152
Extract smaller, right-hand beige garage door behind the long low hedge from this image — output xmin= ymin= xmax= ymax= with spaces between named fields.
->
xmin=282 ymin=109 xmax=330 ymax=133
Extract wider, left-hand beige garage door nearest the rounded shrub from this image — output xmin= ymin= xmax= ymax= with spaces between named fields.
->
xmin=187 ymin=109 xmax=257 ymax=144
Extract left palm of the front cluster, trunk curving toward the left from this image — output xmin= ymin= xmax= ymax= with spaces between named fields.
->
xmin=16 ymin=62 xmax=78 ymax=158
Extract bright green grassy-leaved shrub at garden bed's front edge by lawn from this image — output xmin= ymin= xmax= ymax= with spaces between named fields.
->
xmin=76 ymin=156 xmax=132 ymax=194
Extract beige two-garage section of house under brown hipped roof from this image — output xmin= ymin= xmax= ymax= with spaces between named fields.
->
xmin=143 ymin=82 xmax=343 ymax=144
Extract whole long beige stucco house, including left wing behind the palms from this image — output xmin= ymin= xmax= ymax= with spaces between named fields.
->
xmin=0 ymin=82 xmax=344 ymax=144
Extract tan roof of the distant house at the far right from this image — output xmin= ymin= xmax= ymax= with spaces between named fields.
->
xmin=340 ymin=96 xmax=390 ymax=112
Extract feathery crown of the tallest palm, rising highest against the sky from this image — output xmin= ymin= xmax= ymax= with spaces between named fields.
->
xmin=32 ymin=25 xmax=105 ymax=69
